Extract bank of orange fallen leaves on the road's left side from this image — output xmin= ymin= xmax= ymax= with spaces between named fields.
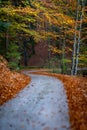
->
xmin=0 ymin=56 xmax=31 ymax=105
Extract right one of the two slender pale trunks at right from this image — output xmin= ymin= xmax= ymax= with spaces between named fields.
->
xmin=74 ymin=1 xmax=84 ymax=75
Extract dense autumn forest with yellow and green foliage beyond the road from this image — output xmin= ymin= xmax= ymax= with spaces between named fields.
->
xmin=0 ymin=0 xmax=87 ymax=75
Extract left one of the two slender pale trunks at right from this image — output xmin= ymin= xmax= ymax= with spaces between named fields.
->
xmin=71 ymin=0 xmax=79 ymax=75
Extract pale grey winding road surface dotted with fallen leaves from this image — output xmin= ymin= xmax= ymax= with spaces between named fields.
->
xmin=0 ymin=71 xmax=70 ymax=130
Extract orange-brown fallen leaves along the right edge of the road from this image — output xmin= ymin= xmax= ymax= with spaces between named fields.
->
xmin=30 ymin=71 xmax=87 ymax=130
